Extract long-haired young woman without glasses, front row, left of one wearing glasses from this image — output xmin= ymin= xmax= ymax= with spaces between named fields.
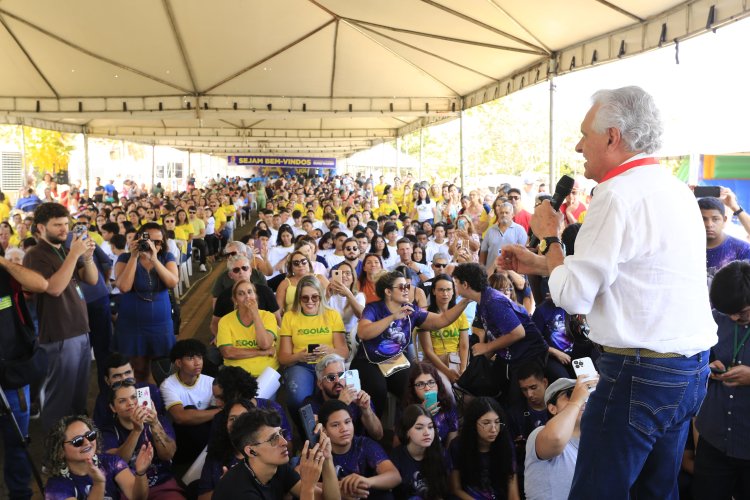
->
xmin=391 ymin=404 xmax=448 ymax=499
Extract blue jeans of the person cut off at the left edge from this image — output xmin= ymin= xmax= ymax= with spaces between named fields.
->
xmin=0 ymin=385 xmax=31 ymax=500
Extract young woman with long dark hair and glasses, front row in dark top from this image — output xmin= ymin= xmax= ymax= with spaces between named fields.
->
xmin=450 ymin=397 xmax=520 ymax=500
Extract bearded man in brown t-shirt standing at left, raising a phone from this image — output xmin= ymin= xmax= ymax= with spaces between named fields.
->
xmin=23 ymin=203 xmax=99 ymax=430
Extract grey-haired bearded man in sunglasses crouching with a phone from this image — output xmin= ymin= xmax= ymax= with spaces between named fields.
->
xmin=302 ymin=354 xmax=383 ymax=441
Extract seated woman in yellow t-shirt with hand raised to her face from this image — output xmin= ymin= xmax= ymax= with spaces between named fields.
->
xmin=216 ymin=280 xmax=279 ymax=377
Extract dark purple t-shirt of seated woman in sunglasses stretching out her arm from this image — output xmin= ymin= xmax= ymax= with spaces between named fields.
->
xmin=357 ymin=300 xmax=428 ymax=363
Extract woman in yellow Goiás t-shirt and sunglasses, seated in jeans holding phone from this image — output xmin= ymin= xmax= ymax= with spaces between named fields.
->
xmin=279 ymin=275 xmax=349 ymax=415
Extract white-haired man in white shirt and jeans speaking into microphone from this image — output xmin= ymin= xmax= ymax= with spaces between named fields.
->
xmin=498 ymin=87 xmax=717 ymax=500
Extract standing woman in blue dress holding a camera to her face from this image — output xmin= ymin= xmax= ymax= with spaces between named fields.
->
xmin=114 ymin=222 xmax=178 ymax=382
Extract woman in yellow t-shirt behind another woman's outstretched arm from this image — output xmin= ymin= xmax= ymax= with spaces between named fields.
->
xmin=417 ymin=274 xmax=469 ymax=384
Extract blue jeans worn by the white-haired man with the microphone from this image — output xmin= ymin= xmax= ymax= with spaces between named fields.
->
xmin=568 ymin=351 xmax=709 ymax=500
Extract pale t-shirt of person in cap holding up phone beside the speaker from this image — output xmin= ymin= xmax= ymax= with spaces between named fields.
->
xmin=524 ymin=426 xmax=578 ymax=500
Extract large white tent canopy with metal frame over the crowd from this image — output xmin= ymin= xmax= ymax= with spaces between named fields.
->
xmin=0 ymin=0 xmax=750 ymax=157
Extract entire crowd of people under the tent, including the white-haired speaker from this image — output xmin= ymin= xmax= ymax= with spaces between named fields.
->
xmin=0 ymin=88 xmax=750 ymax=500
